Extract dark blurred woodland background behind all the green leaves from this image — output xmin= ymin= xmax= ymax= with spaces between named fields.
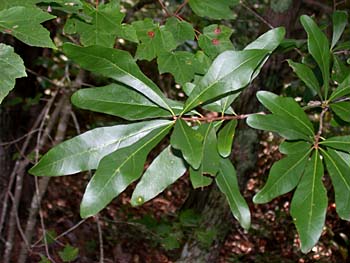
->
xmin=0 ymin=0 xmax=350 ymax=263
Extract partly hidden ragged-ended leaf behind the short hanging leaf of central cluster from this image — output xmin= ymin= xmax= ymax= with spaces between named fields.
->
xmin=190 ymin=122 xmax=220 ymax=188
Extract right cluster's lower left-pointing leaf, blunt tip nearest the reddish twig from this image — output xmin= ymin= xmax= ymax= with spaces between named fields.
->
xmin=247 ymin=114 xmax=312 ymax=141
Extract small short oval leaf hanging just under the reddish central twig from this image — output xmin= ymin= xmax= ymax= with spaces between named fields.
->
xmin=218 ymin=120 xmax=237 ymax=158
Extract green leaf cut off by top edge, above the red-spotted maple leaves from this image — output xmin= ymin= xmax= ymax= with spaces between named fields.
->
xmin=188 ymin=0 xmax=239 ymax=19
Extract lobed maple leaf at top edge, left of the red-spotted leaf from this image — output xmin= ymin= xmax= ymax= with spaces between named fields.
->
xmin=72 ymin=1 xmax=124 ymax=48
